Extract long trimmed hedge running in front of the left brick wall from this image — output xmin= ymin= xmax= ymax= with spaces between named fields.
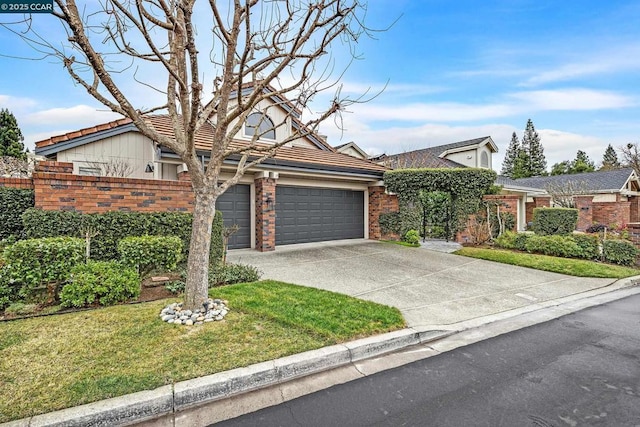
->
xmin=22 ymin=209 xmax=223 ymax=262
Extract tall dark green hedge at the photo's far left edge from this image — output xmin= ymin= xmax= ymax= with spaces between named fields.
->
xmin=0 ymin=187 xmax=35 ymax=240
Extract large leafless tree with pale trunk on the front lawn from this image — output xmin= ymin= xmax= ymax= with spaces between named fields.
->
xmin=3 ymin=0 xmax=376 ymax=308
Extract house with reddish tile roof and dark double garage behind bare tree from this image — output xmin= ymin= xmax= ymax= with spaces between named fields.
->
xmin=36 ymin=91 xmax=396 ymax=250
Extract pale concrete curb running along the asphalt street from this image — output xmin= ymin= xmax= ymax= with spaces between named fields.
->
xmin=6 ymin=276 xmax=640 ymax=427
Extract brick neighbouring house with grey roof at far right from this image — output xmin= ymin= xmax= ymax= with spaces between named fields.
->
xmin=510 ymin=168 xmax=640 ymax=230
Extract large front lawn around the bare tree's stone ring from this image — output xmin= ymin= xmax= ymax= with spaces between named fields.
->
xmin=0 ymin=281 xmax=404 ymax=422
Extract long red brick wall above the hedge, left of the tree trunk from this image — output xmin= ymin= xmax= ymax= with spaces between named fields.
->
xmin=32 ymin=162 xmax=193 ymax=213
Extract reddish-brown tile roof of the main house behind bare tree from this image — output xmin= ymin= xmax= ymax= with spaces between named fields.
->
xmin=36 ymin=115 xmax=387 ymax=175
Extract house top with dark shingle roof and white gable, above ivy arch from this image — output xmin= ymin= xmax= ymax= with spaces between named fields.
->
xmin=371 ymin=136 xmax=498 ymax=169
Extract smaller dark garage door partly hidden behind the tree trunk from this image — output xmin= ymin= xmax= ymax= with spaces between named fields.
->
xmin=216 ymin=184 xmax=251 ymax=249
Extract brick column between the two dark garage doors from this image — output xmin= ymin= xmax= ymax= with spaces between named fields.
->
xmin=254 ymin=172 xmax=276 ymax=252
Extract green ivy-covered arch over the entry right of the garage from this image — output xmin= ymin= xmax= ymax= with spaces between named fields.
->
xmin=380 ymin=168 xmax=497 ymax=237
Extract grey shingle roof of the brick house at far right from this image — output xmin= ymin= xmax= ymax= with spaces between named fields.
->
xmin=511 ymin=168 xmax=633 ymax=191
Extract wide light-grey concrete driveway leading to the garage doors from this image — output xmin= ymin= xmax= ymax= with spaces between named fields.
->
xmin=228 ymin=240 xmax=615 ymax=330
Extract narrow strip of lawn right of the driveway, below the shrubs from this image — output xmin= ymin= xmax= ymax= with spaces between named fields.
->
xmin=454 ymin=247 xmax=640 ymax=279
